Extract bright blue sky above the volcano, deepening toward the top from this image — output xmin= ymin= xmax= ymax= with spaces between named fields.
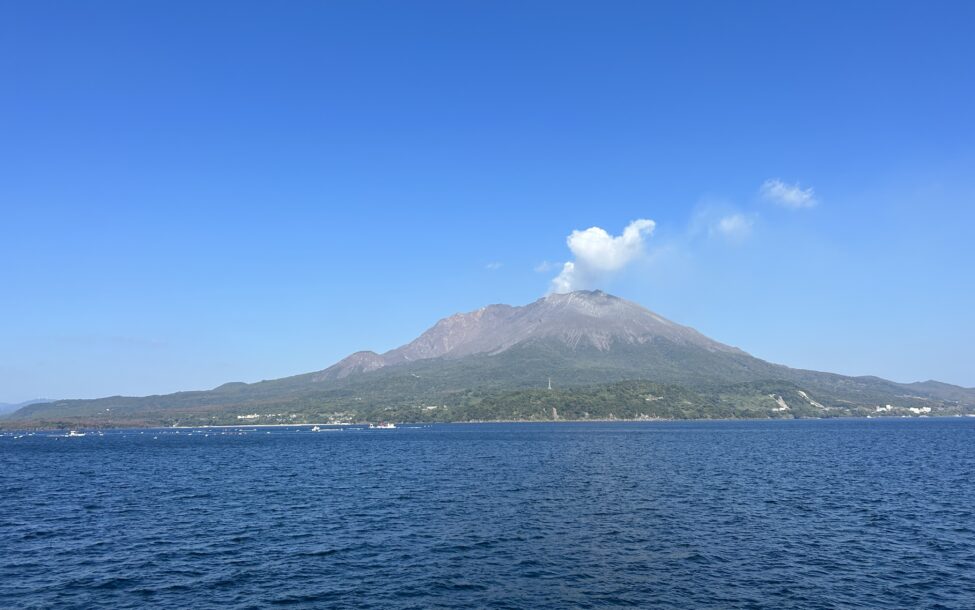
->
xmin=0 ymin=0 xmax=975 ymax=402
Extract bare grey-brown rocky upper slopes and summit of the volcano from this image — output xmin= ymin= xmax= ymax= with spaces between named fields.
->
xmin=320 ymin=290 xmax=743 ymax=380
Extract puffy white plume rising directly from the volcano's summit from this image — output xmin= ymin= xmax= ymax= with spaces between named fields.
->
xmin=552 ymin=219 xmax=656 ymax=292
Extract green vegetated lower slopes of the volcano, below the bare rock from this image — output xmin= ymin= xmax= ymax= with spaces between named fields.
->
xmin=0 ymin=340 xmax=975 ymax=427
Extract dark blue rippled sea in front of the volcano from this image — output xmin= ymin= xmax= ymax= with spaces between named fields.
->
xmin=0 ymin=419 xmax=975 ymax=609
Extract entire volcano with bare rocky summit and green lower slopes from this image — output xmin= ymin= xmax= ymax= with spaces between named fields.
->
xmin=13 ymin=291 xmax=975 ymax=425
